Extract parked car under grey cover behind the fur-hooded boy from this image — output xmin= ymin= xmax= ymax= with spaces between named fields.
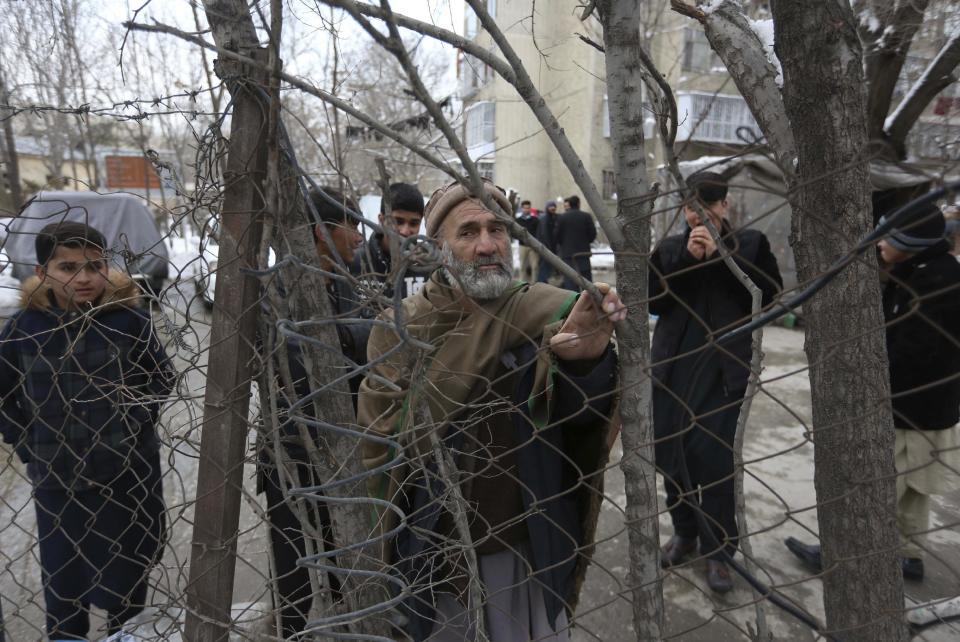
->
xmin=3 ymin=192 xmax=168 ymax=292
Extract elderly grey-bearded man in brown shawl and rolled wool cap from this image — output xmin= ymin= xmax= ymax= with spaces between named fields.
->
xmin=358 ymin=181 xmax=626 ymax=642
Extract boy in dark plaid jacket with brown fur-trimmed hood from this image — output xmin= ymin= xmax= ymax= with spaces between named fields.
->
xmin=0 ymin=222 xmax=172 ymax=639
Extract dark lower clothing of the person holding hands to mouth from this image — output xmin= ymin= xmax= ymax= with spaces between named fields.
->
xmin=653 ymin=378 xmax=743 ymax=560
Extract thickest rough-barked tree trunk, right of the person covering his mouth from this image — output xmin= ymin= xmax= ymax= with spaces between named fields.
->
xmin=772 ymin=0 xmax=907 ymax=642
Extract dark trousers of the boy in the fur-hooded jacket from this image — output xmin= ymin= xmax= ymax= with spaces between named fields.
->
xmin=34 ymin=454 xmax=166 ymax=640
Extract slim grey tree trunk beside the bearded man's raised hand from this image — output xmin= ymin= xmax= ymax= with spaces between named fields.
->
xmin=597 ymin=0 xmax=663 ymax=640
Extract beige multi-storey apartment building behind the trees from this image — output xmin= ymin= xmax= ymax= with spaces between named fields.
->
xmin=457 ymin=0 xmax=960 ymax=207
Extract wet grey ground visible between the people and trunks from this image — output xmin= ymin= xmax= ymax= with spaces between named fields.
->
xmin=0 ymin=292 xmax=960 ymax=642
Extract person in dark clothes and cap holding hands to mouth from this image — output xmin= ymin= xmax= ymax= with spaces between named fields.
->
xmin=650 ymin=172 xmax=783 ymax=593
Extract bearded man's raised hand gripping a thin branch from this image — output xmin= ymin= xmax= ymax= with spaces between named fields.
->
xmin=550 ymin=283 xmax=627 ymax=361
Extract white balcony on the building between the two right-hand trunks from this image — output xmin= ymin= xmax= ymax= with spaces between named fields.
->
xmin=677 ymin=92 xmax=762 ymax=145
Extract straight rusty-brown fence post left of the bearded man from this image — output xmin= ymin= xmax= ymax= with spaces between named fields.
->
xmin=185 ymin=50 xmax=267 ymax=642
